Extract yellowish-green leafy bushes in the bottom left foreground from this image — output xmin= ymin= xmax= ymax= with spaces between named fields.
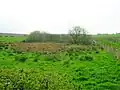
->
xmin=0 ymin=69 xmax=73 ymax=90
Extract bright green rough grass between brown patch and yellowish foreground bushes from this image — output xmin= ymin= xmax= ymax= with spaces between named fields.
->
xmin=0 ymin=48 xmax=120 ymax=90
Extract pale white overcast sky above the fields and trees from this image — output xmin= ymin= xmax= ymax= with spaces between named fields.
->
xmin=0 ymin=0 xmax=120 ymax=34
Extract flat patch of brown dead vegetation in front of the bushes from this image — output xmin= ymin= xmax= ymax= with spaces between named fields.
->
xmin=9 ymin=43 xmax=65 ymax=52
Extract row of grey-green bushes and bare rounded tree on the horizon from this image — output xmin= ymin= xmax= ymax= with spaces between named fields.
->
xmin=24 ymin=26 xmax=92 ymax=45
